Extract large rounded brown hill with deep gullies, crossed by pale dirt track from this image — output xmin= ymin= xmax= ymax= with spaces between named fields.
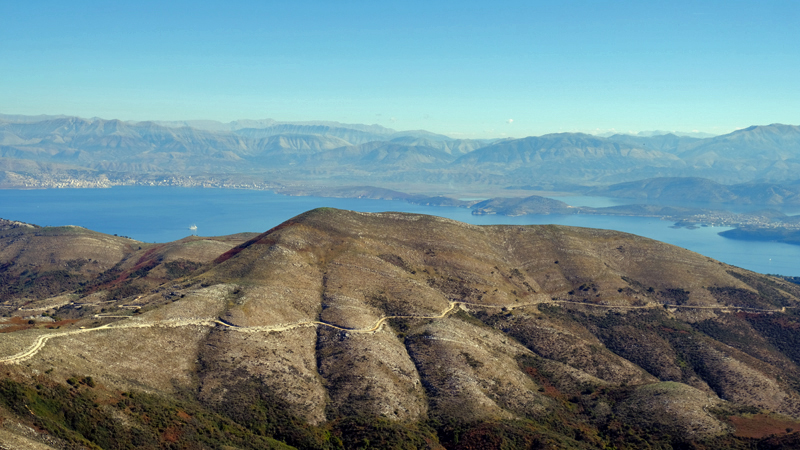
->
xmin=0 ymin=208 xmax=800 ymax=448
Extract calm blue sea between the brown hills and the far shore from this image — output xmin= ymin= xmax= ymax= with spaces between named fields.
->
xmin=0 ymin=186 xmax=800 ymax=276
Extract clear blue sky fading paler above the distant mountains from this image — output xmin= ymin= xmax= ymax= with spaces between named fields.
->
xmin=0 ymin=0 xmax=800 ymax=137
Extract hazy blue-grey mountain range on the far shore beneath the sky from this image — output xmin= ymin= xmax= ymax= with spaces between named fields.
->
xmin=0 ymin=115 xmax=800 ymax=189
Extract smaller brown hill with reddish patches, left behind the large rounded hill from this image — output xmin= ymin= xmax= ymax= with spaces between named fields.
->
xmin=0 ymin=219 xmax=254 ymax=317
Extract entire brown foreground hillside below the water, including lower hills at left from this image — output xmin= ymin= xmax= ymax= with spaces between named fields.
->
xmin=0 ymin=208 xmax=800 ymax=449
